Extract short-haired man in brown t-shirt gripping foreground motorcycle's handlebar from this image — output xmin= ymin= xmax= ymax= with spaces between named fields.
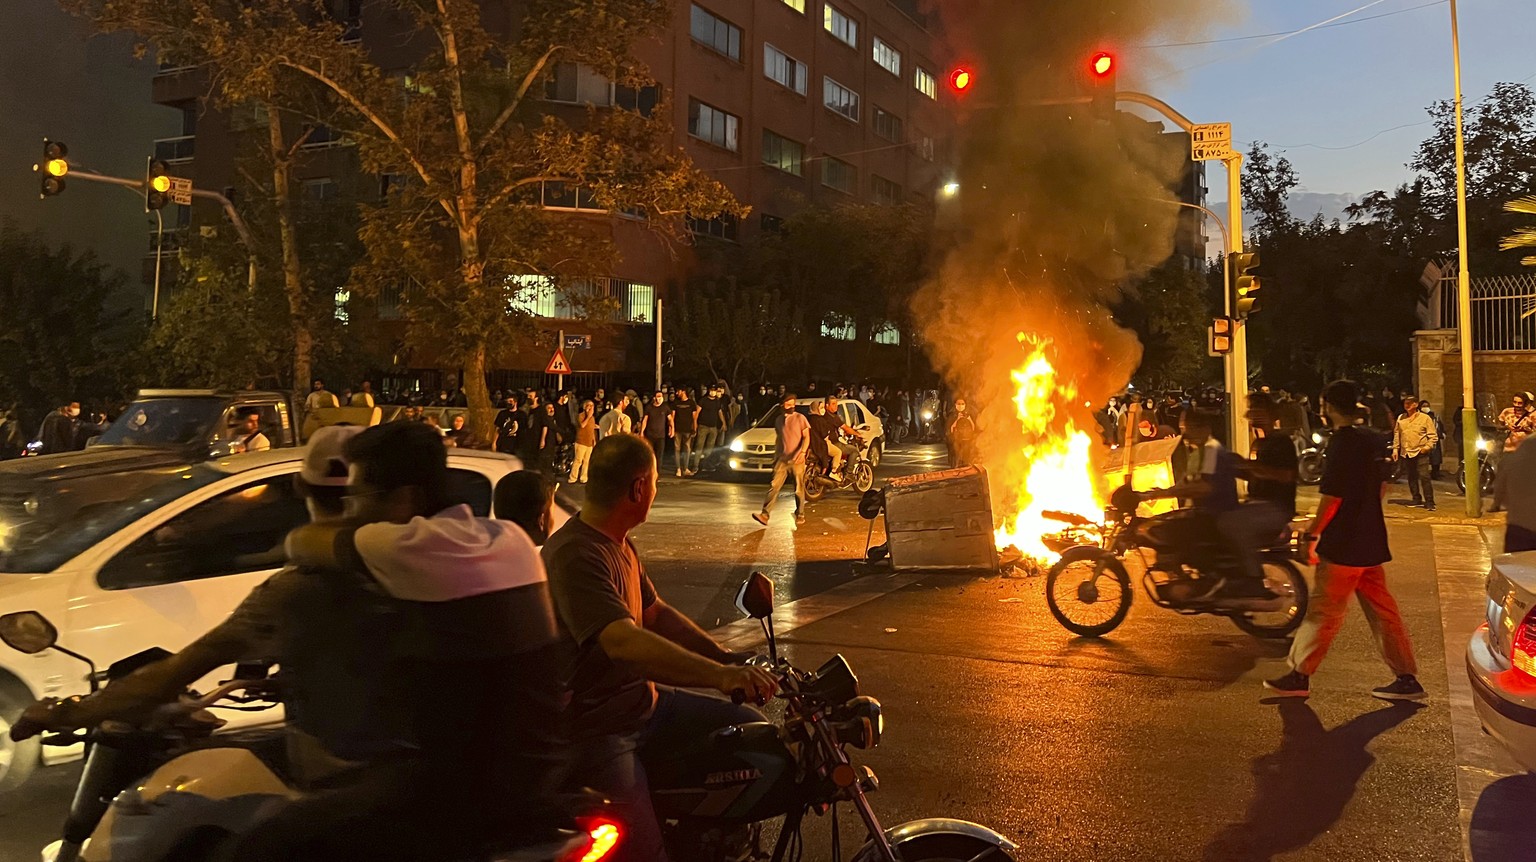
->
xmin=542 ymin=435 xmax=777 ymax=862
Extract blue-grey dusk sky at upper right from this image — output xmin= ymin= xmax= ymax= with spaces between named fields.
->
xmin=1120 ymin=0 xmax=1536 ymax=200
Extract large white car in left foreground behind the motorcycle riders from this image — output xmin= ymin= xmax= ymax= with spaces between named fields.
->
xmin=0 ymin=446 xmax=521 ymax=790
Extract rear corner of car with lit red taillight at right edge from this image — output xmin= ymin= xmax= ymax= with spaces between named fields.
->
xmin=1467 ymin=552 xmax=1536 ymax=771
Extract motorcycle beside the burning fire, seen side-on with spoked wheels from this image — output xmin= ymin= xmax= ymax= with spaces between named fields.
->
xmin=1046 ymin=486 xmax=1307 ymax=638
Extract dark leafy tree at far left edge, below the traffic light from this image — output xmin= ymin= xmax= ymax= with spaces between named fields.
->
xmin=0 ymin=218 xmax=143 ymax=421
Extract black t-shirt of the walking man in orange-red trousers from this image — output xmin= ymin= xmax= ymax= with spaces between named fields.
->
xmin=1318 ymin=426 xmax=1392 ymax=567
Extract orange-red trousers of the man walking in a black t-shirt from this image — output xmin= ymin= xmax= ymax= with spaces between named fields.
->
xmin=1290 ymin=559 xmax=1418 ymax=676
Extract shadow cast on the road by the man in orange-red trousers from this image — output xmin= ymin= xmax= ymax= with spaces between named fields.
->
xmin=1204 ymin=698 xmax=1419 ymax=862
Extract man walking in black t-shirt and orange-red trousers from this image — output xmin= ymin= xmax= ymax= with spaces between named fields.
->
xmin=1264 ymin=380 xmax=1424 ymax=701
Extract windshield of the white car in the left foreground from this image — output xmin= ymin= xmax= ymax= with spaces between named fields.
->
xmin=0 ymin=464 xmax=227 ymax=575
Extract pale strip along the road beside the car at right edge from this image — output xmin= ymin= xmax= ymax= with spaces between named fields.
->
xmin=1430 ymin=524 xmax=1521 ymax=862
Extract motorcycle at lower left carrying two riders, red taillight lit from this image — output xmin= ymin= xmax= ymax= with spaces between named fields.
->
xmin=0 ymin=612 xmax=621 ymax=862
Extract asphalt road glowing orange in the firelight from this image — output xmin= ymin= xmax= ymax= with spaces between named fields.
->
xmin=0 ymin=450 xmax=1536 ymax=862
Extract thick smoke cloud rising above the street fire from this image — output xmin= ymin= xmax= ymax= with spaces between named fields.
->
xmin=914 ymin=0 xmax=1220 ymax=515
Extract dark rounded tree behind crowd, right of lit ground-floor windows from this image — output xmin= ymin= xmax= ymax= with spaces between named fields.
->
xmin=665 ymin=284 xmax=806 ymax=390
